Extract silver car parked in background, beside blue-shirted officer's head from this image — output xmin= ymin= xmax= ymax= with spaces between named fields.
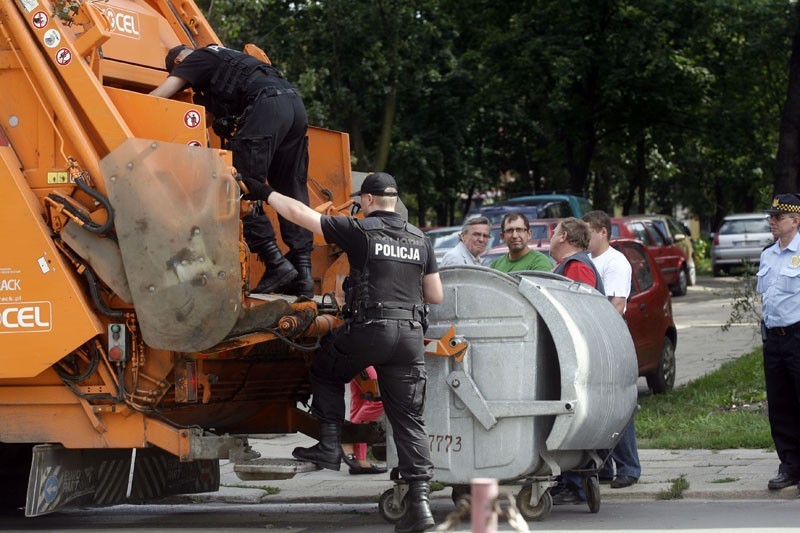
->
xmin=711 ymin=213 xmax=775 ymax=276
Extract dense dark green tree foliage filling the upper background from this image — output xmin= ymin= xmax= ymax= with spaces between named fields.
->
xmin=200 ymin=0 xmax=797 ymax=225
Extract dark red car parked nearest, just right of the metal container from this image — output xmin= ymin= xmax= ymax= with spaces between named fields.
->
xmin=611 ymin=239 xmax=678 ymax=394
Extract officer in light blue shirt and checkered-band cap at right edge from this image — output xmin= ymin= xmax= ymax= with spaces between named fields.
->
xmin=757 ymin=193 xmax=800 ymax=490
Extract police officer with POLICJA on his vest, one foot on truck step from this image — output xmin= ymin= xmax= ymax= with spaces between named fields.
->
xmin=244 ymin=172 xmax=443 ymax=532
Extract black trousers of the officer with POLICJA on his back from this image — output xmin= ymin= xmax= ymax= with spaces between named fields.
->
xmin=311 ymin=320 xmax=433 ymax=481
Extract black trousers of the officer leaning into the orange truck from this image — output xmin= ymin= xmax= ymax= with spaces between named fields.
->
xmin=230 ymin=92 xmax=313 ymax=255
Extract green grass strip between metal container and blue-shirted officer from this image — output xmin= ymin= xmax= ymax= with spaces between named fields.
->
xmin=636 ymin=348 xmax=773 ymax=450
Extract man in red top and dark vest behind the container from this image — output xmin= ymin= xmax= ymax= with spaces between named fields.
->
xmin=550 ymin=217 xmax=603 ymax=292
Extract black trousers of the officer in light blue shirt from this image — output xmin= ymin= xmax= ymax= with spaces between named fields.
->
xmin=764 ymin=329 xmax=800 ymax=477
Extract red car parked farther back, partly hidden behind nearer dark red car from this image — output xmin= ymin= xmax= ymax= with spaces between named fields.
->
xmin=611 ymin=217 xmax=689 ymax=296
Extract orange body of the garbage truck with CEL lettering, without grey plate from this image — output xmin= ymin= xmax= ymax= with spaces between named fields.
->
xmin=0 ymin=0 xmax=352 ymax=494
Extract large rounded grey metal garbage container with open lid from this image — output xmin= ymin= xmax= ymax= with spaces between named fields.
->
xmin=387 ymin=266 xmax=638 ymax=512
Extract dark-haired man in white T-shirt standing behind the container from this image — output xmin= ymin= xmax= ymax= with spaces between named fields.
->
xmin=583 ymin=211 xmax=642 ymax=489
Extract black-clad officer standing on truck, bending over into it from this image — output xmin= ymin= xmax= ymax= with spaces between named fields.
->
xmin=150 ymin=45 xmax=314 ymax=296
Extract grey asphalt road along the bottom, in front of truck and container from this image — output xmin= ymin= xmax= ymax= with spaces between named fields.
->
xmin=0 ymin=500 xmax=800 ymax=533
